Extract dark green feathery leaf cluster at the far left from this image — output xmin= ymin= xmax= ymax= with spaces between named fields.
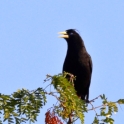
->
xmin=0 ymin=88 xmax=46 ymax=124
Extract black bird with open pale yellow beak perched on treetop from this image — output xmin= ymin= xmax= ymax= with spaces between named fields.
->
xmin=59 ymin=29 xmax=92 ymax=102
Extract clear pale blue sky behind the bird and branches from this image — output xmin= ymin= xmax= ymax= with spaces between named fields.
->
xmin=0 ymin=0 xmax=124 ymax=124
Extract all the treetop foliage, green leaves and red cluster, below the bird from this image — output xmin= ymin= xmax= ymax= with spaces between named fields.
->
xmin=0 ymin=73 xmax=124 ymax=124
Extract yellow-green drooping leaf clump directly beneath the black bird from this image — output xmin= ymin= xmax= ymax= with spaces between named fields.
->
xmin=51 ymin=73 xmax=87 ymax=123
